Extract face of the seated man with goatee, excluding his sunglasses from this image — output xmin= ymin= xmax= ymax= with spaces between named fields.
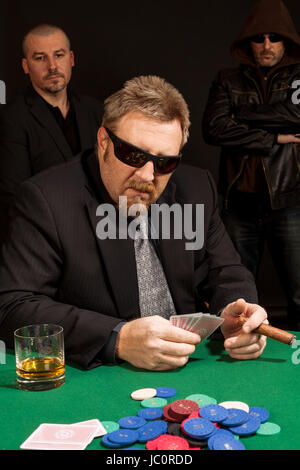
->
xmin=98 ymin=112 xmax=182 ymax=208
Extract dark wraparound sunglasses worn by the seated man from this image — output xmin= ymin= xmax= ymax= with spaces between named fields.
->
xmin=104 ymin=127 xmax=182 ymax=175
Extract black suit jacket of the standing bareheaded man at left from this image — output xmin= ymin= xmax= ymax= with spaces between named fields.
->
xmin=0 ymin=87 xmax=103 ymax=245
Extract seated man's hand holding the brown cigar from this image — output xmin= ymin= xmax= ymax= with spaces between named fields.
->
xmin=221 ymin=299 xmax=268 ymax=360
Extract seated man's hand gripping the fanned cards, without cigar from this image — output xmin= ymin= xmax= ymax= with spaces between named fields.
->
xmin=117 ymin=315 xmax=201 ymax=370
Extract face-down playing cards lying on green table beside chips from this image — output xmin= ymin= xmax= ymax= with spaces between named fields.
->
xmin=20 ymin=419 xmax=107 ymax=450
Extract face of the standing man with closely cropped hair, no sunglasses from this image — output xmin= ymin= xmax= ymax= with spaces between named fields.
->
xmin=22 ymin=31 xmax=74 ymax=95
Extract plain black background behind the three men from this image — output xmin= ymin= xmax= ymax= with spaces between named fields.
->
xmin=0 ymin=0 xmax=300 ymax=324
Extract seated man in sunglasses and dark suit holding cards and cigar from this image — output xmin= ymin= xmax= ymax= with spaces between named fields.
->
xmin=0 ymin=76 xmax=267 ymax=370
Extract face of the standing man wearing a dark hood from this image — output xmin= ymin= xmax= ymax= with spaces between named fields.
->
xmin=251 ymin=34 xmax=285 ymax=67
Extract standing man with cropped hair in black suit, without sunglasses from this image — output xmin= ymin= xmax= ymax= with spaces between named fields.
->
xmin=0 ymin=25 xmax=103 ymax=245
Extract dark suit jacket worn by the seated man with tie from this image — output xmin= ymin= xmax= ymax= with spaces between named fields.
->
xmin=0 ymin=152 xmax=257 ymax=368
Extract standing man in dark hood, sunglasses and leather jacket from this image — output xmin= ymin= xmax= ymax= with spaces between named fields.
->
xmin=203 ymin=0 xmax=300 ymax=330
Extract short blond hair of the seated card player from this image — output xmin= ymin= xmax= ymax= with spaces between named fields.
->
xmin=102 ymin=75 xmax=190 ymax=147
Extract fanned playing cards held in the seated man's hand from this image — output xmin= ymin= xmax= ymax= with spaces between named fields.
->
xmin=170 ymin=313 xmax=224 ymax=341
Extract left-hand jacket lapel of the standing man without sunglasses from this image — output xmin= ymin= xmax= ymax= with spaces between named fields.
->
xmin=27 ymin=87 xmax=72 ymax=161
